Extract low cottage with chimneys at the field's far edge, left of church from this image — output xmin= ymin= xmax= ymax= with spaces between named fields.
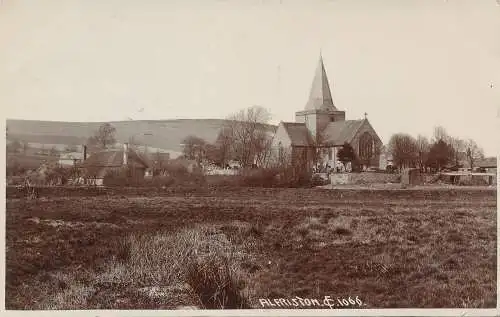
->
xmin=80 ymin=143 xmax=149 ymax=185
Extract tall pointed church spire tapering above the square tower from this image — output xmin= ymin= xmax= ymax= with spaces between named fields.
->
xmin=306 ymin=52 xmax=337 ymax=110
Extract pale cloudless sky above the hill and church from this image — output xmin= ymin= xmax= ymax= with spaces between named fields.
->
xmin=0 ymin=0 xmax=500 ymax=155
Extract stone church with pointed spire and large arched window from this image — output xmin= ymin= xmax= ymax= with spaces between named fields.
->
xmin=272 ymin=56 xmax=382 ymax=169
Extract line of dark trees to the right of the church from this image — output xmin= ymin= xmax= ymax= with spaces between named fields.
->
xmin=388 ymin=126 xmax=484 ymax=171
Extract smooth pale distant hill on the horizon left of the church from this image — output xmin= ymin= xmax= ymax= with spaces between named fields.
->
xmin=7 ymin=119 xmax=275 ymax=152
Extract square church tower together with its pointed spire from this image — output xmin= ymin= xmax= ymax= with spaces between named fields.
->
xmin=295 ymin=55 xmax=345 ymax=142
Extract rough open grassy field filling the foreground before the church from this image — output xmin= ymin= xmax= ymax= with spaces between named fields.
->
xmin=6 ymin=188 xmax=497 ymax=309
